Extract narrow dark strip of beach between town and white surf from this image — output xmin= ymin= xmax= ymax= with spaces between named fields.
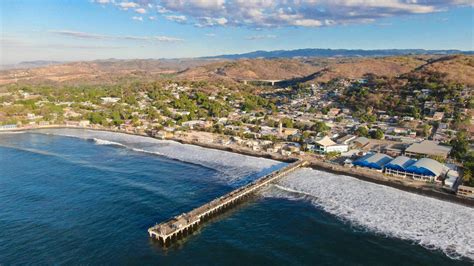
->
xmin=0 ymin=125 xmax=474 ymax=208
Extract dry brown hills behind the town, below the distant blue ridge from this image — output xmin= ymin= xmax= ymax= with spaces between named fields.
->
xmin=0 ymin=55 xmax=474 ymax=85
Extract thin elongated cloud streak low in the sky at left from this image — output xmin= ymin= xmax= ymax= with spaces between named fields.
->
xmin=49 ymin=30 xmax=184 ymax=42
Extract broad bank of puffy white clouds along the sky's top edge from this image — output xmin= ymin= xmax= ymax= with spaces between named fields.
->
xmin=94 ymin=0 xmax=474 ymax=28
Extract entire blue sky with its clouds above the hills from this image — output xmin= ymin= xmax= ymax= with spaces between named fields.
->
xmin=0 ymin=0 xmax=474 ymax=64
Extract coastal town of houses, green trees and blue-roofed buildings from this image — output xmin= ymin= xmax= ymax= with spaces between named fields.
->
xmin=0 ymin=71 xmax=474 ymax=202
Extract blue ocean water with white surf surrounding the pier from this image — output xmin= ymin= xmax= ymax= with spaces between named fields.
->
xmin=0 ymin=129 xmax=474 ymax=265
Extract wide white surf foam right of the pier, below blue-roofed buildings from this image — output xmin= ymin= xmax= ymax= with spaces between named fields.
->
xmin=263 ymin=168 xmax=474 ymax=259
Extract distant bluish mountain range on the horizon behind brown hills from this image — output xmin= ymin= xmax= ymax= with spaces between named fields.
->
xmin=201 ymin=48 xmax=474 ymax=59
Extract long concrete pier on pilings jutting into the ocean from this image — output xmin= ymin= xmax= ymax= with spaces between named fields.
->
xmin=148 ymin=161 xmax=307 ymax=245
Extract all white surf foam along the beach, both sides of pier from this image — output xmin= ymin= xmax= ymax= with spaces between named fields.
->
xmin=37 ymin=129 xmax=474 ymax=260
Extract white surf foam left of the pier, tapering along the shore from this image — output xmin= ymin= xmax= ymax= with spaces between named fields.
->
xmin=35 ymin=129 xmax=282 ymax=185
